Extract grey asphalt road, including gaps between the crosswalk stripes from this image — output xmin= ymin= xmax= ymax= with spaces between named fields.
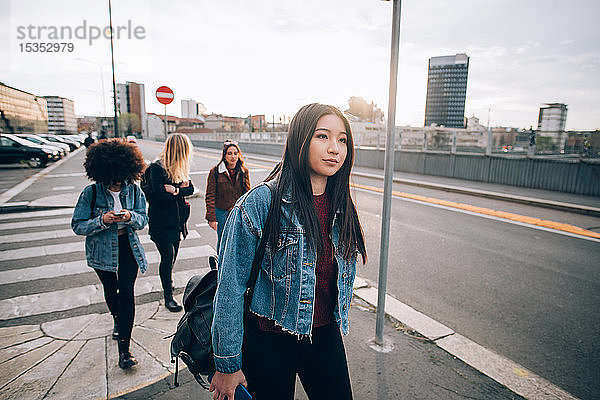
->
xmin=0 ymin=141 xmax=600 ymax=399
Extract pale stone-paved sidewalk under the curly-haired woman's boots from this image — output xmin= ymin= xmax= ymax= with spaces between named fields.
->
xmin=0 ymin=295 xmax=182 ymax=400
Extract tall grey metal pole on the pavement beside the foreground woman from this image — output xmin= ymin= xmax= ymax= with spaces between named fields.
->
xmin=375 ymin=0 xmax=401 ymax=346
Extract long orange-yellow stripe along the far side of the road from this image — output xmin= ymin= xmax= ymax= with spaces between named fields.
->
xmin=351 ymin=183 xmax=600 ymax=241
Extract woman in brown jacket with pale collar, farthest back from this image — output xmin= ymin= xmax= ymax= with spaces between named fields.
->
xmin=205 ymin=140 xmax=250 ymax=251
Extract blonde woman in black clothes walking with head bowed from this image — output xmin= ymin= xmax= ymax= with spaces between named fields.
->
xmin=142 ymin=133 xmax=194 ymax=312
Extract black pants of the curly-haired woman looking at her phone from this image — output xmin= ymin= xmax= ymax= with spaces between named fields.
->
xmin=94 ymin=235 xmax=138 ymax=341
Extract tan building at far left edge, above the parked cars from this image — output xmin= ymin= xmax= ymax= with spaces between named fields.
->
xmin=0 ymin=82 xmax=48 ymax=133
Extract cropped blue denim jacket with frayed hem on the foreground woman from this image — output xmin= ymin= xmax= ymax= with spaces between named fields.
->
xmin=212 ymin=184 xmax=356 ymax=373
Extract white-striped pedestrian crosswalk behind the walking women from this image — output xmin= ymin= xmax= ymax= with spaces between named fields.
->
xmin=0 ymin=208 xmax=215 ymax=325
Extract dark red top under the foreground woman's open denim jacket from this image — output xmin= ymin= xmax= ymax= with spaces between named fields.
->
xmin=258 ymin=193 xmax=337 ymax=332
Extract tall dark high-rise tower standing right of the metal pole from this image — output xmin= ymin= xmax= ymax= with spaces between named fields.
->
xmin=425 ymin=53 xmax=469 ymax=128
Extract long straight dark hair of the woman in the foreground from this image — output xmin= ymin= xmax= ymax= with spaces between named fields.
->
xmin=265 ymin=103 xmax=367 ymax=263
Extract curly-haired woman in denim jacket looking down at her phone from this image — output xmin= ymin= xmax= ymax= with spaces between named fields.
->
xmin=71 ymin=139 xmax=148 ymax=369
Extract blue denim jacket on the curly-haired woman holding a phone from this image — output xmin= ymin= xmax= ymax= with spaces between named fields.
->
xmin=71 ymin=183 xmax=148 ymax=273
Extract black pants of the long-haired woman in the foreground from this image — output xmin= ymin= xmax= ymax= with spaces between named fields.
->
xmin=242 ymin=318 xmax=352 ymax=400
